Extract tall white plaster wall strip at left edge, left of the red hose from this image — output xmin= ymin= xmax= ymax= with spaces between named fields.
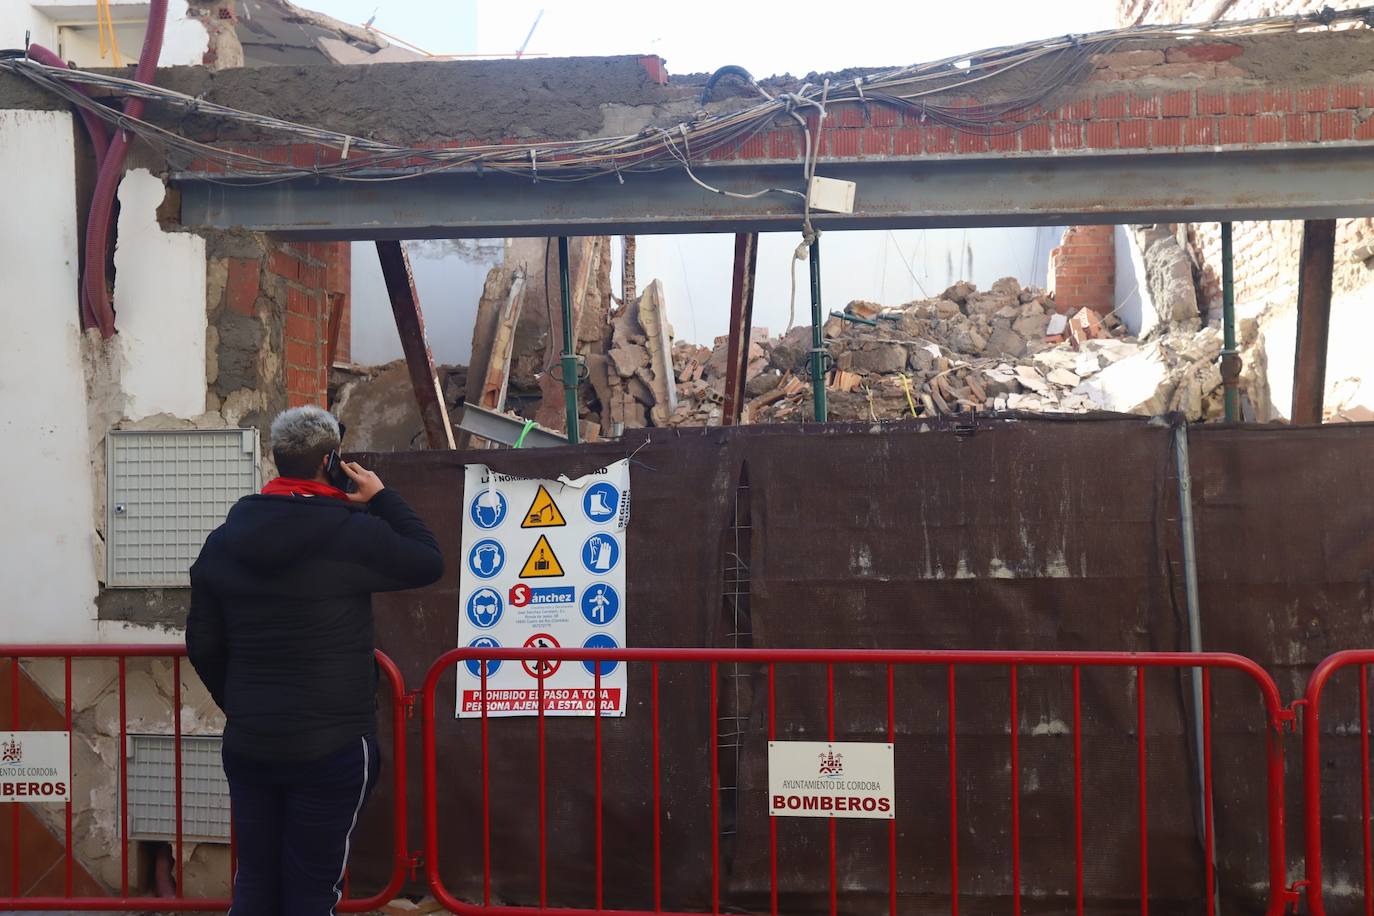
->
xmin=0 ymin=110 xmax=102 ymax=643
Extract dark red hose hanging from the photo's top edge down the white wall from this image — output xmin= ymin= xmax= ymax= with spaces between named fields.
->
xmin=82 ymin=0 xmax=168 ymax=339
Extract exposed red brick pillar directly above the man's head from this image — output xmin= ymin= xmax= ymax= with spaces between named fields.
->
xmin=268 ymin=242 xmax=350 ymax=407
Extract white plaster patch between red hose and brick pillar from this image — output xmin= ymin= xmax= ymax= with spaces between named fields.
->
xmin=114 ymin=169 xmax=207 ymax=420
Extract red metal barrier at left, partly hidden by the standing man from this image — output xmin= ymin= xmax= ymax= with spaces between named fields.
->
xmin=0 ymin=644 xmax=411 ymax=913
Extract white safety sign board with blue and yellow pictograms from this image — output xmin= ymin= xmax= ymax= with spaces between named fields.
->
xmin=458 ymin=459 xmax=629 ymax=718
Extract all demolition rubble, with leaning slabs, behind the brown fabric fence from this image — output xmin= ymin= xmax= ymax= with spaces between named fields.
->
xmin=343 ymin=269 xmax=1221 ymax=450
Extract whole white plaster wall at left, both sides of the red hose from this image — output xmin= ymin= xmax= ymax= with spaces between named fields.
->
xmin=0 ymin=120 xmax=214 ymax=643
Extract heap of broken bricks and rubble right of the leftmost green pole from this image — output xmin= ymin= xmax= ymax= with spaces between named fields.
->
xmin=464 ymin=265 xmax=1216 ymax=437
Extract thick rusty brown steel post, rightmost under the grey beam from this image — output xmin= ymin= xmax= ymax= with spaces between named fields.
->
xmin=1290 ymin=220 xmax=1336 ymax=423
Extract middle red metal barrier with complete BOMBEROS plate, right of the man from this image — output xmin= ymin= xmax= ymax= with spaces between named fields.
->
xmin=422 ymin=648 xmax=1287 ymax=916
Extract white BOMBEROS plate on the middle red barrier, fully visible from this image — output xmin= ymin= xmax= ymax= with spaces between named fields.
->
xmin=768 ymin=742 xmax=897 ymax=820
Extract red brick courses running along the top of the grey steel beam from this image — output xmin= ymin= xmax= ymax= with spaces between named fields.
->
xmin=190 ymin=42 xmax=1374 ymax=173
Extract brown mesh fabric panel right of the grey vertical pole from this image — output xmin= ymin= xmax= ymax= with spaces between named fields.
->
xmin=1191 ymin=423 xmax=1374 ymax=915
